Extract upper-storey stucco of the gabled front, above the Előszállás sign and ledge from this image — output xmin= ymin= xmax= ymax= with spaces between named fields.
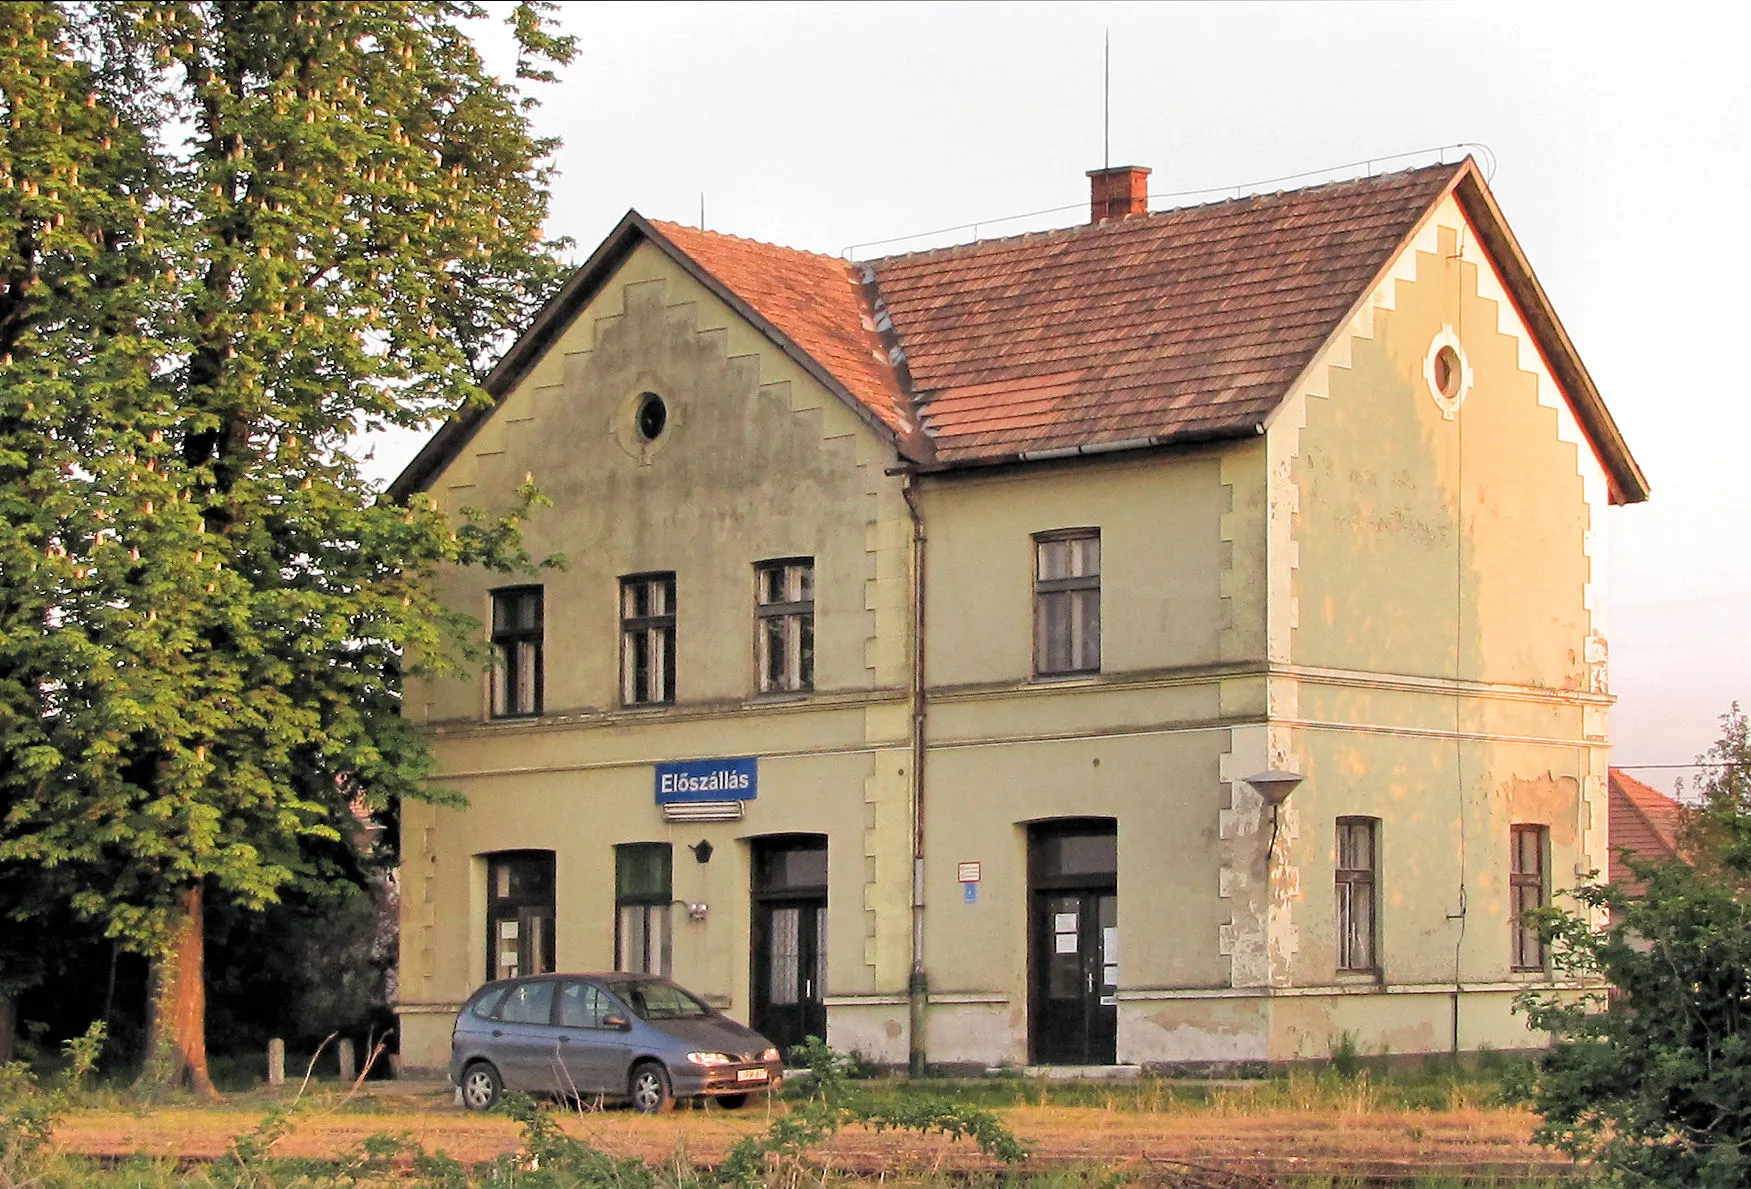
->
xmin=404 ymin=245 xmax=907 ymax=721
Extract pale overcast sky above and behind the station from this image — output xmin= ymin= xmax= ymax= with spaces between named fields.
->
xmin=362 ymin=4 xmax=1751 ymax=790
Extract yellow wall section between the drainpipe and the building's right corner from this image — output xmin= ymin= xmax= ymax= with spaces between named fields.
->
xmin=919 ymin=443 xmax=1264 ymax=1065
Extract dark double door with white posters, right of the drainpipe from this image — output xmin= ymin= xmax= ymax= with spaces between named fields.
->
xmin=1028 ymin=818 xmax=1119 ymax=1065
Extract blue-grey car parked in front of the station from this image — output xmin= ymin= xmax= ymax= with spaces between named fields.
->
xmin=450 ymin=974 xmax=783 ymax=1114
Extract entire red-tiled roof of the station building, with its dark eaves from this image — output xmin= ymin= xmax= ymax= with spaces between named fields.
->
xmin=389 ymin=158 xmax=1648 ymax=503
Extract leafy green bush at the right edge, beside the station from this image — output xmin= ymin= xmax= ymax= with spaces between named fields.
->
xmin=1523 ymin=704 xmax=1751 ymax=1189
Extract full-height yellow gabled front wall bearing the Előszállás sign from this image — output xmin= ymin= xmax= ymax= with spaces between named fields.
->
xmin=401 ymin=245 xmax=911 ymax=1066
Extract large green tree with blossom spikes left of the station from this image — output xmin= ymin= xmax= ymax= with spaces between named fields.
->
xmin=0 ymin=0 xmax=571 ymax=1089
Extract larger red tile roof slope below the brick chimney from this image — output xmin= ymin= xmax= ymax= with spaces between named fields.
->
xmin=872 ymin=165 xmax=1462 ymax=462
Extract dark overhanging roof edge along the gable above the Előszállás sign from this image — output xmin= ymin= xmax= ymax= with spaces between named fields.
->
xmin=385 ymin=210 xmax=930 ymax=503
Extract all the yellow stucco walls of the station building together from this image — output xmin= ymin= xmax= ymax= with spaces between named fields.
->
xmin=401 ymin=203 xmax=1609 ymax=1065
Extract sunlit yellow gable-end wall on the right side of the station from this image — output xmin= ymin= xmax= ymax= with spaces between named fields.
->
xmin=1264 ymin=200 xmax=1609 ymax=1058
